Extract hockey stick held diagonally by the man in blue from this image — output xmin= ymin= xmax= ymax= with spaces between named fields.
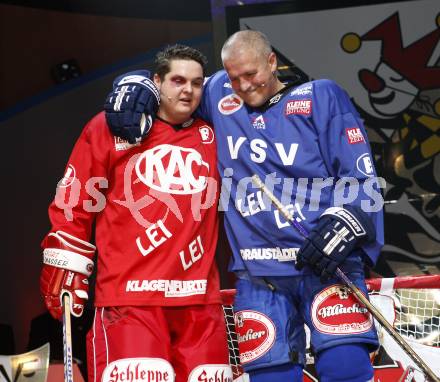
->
xmin=252 ymin=175 xmax=440 ymax=382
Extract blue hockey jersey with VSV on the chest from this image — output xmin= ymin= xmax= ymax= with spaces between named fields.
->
xmin=199 ymin=71 xmax=383 ymax=276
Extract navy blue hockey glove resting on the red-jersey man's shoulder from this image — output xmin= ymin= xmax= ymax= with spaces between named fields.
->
xmin=104 ymin=70 xmax=160 ymax=143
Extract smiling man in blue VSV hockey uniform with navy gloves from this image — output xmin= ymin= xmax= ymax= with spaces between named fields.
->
xmin=105 ymin=31 xmax=383 ymax=382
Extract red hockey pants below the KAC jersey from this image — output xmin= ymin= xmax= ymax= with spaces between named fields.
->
xmin=87 ymin=305 xmax=229 ymax=382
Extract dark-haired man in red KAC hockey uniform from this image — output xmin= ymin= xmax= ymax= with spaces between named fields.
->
xmin=40 ymin=45 xmax=232 ymax=382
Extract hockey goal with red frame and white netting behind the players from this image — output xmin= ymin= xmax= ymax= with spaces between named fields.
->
xmin=222 ymin=275 xmax=440 ymax=382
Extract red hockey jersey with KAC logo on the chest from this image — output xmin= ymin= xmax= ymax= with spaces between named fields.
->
xmin=43 ymin=113 xmax=220 ymax=306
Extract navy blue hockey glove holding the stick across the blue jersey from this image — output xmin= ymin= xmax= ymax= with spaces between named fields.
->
xmin=295 ymin=206 xmax=376 ymax=282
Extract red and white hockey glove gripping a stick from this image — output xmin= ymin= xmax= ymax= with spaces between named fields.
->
xmin=40 ymin=231 xmax=96 ymax=319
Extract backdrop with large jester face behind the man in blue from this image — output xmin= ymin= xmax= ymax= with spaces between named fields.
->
xmin=223 ymin=0 xmax=440 ymax=274
